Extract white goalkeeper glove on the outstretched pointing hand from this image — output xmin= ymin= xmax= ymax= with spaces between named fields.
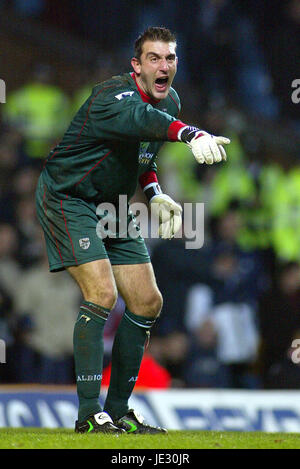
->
xmin=178 ymin=126 xmax=230 ymax=164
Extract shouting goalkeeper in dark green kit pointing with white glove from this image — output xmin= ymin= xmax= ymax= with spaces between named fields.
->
xmin=36 ymin=27 xmax=229 ymax=433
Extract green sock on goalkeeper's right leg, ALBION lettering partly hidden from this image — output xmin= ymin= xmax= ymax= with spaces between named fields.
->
xmin=104 ymin=308 xmax=155 ymax=420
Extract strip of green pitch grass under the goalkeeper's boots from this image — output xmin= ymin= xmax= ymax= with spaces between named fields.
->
xmin=0 ymin=428 xmax=300 ymax=450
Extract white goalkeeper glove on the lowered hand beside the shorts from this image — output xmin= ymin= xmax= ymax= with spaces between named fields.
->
xmin=144 ymin=182 xmax=182 ymax=239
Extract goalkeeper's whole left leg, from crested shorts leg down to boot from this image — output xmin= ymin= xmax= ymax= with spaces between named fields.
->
xmin=36 ymin=180 xmax=124 ymax=433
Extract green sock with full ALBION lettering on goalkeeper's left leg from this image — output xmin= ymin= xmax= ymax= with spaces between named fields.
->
xmin=73 ymin=301 xmax=110 ymax=422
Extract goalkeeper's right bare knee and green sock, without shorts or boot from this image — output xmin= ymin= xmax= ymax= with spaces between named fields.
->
xmin=104 ymin=263 xmax=162 ymax=426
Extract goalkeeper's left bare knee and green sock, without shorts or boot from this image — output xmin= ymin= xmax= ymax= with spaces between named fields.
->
xmin=67 ymin=259 xmax=117 ymax=423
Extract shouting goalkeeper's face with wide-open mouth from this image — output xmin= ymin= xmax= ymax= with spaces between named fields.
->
xmin=131 ymin=41 xmax=177 ymax=99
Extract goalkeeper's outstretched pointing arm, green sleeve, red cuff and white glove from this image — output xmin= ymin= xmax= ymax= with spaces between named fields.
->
xmin=89 ymin=87 xmax=230 ymax=159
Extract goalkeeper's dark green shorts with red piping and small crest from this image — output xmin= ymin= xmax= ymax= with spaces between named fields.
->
xmin=36 ymin=175 xmax=150 ymax=272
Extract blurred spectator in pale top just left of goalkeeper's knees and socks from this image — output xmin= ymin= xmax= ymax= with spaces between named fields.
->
xmin=13 ymin=247 xmax=80 ymax=384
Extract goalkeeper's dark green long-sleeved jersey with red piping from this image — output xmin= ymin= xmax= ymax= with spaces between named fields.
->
xmin=42 ymin=73 xmax=180 ymax=203
